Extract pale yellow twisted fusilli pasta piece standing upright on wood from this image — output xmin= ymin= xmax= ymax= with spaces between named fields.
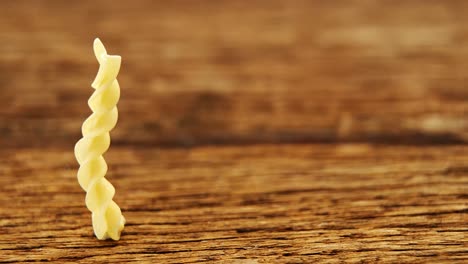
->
xmin=75 ymin=39 xmax=125 ymax=240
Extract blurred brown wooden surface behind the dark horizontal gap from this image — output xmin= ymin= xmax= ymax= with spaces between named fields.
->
xmin=0 ymin=0 xmax=468 ymax=149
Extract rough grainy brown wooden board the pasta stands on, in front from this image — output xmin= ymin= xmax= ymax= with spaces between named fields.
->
xmin=0 ymin=144 xmax=468 ymax=263
